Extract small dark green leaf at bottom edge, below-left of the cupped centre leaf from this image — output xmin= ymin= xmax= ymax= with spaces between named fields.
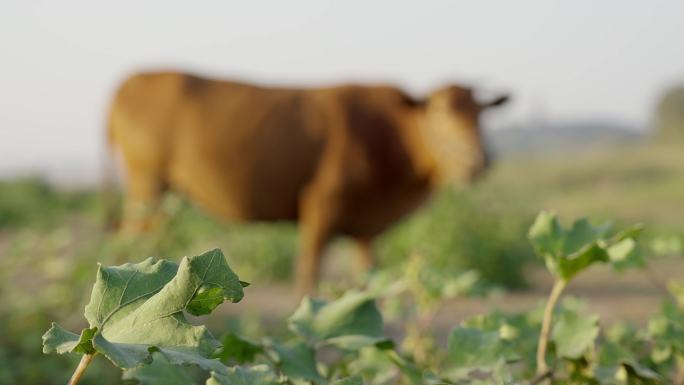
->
xmin=266 ymin=341 xmax=324 ymax=381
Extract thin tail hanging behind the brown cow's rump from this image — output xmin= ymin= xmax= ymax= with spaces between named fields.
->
xmin=100 ymin=111 xmax=121 ymax=231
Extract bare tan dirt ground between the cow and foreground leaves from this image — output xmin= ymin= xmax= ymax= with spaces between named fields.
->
xmin=215 ymin=257 xmax=684 ymax=335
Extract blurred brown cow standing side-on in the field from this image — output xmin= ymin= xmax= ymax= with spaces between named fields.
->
xmin=109 ymin=72 xmax=507 ymax=292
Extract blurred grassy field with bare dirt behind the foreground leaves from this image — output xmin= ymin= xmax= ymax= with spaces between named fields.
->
xmin=0 ymin=142 xmax=684 ymax=384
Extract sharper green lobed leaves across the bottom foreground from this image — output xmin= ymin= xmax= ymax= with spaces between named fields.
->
xmin=44 ymin=213 xmax=684 ymax=385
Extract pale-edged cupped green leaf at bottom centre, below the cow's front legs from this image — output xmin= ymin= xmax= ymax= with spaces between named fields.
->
xmin=289 ymin=291 xmax=384 ymax=349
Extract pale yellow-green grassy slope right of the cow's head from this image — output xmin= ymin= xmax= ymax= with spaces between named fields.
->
xmin=487 ymin=142 xmax=684 ymax=233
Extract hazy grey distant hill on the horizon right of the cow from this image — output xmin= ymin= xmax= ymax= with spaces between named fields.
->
xmin=487 ymin=122 xmax=648 ymax=156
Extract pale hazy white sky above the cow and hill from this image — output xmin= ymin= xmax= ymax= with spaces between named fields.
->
xmin=0 ymin=0 xmax=684 ymax=181
